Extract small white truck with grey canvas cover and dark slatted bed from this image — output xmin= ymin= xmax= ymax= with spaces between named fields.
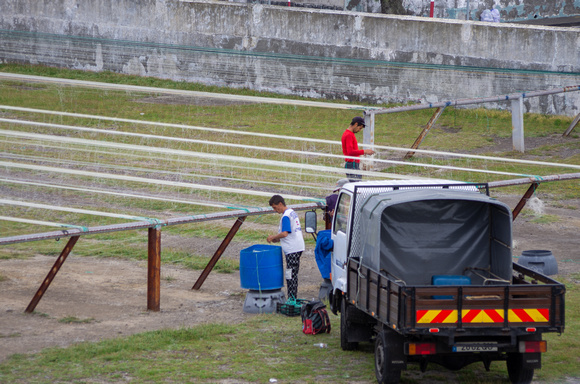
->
xmin=314 ymin=180 xmax=565 ymax=384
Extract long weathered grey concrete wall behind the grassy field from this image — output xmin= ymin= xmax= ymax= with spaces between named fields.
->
xmin=0 ymin=0 xmax=580 ymax=115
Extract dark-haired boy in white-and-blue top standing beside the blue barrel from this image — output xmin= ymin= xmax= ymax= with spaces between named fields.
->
xmin=267 ymin=195 xmax=305 ymax=301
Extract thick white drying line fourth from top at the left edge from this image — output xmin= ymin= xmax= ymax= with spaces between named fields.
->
xmin=0 ymin=130 xmax=416 ymax=180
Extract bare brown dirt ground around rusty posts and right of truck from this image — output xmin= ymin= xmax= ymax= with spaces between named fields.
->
xmin=0 ymin=192 xmax=580 ymax=362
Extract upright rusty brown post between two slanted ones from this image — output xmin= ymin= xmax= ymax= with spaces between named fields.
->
xmin=147 ymin=227 xmax=161 ymax=312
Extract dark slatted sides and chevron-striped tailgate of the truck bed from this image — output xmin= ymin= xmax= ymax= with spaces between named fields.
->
xmin=347 ymin=258 xmax=565 ymax=337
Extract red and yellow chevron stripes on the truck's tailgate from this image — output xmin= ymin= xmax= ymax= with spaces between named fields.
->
xmin=416 ymin=308 xmax=550 ymax=324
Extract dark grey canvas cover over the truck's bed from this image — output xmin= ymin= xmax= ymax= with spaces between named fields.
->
xmin=353 ymin=189 xmax=512 ymax=285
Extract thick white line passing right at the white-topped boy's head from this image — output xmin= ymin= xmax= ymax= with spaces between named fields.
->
xmin=0 ymin=161 xmax=322 ymax=201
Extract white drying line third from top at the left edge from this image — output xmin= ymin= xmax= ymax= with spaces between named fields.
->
xmin=0 ymin=122 xmax=530 ymax=178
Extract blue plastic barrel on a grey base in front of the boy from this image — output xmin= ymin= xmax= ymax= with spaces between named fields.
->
xmin=240 ymin=244 xmax=284 ymax=291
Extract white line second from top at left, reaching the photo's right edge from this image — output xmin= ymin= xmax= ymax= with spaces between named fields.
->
xmin=0 ymin=105 xmax=580 ymax=169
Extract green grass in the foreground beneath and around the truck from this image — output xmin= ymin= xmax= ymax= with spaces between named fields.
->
xmin=0 ymin=290 xmax=580 ymax=384
